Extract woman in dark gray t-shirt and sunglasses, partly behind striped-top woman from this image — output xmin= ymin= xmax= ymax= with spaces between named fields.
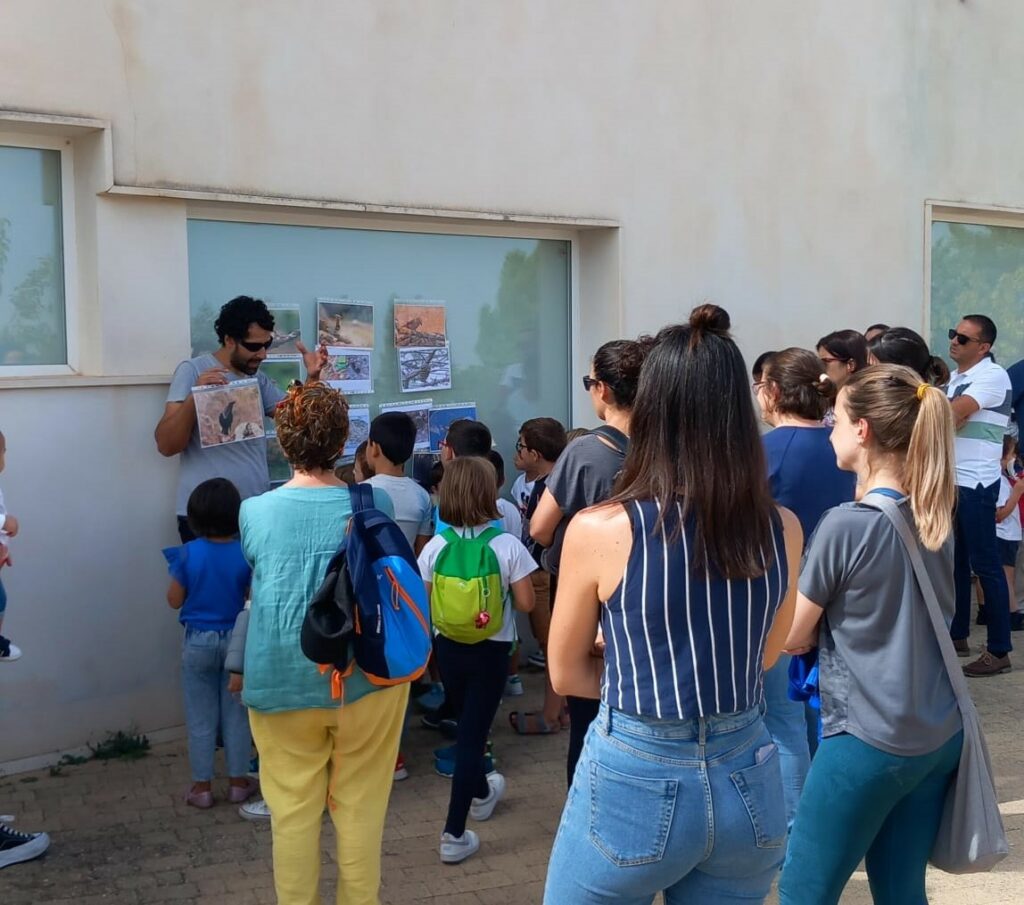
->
xmin=528 ymin=336 xmax=654 ymax=786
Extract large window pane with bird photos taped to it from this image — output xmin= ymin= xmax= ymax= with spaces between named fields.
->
xmin=188 ymin=220 xmax=569 ymax=470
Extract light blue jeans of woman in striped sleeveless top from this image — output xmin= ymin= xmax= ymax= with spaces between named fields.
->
xmin=544 ymin=703 xmax=786 ymax=905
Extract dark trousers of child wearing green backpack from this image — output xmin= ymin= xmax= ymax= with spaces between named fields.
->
xmin=434 ymin=635 xmax=512 ymax=836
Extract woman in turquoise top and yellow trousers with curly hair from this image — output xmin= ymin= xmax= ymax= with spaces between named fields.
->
xmin=240 ymin=382 xmax=409 ymax=905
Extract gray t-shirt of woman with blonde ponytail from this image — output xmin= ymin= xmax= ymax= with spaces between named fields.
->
xmin=800 ymin=500 xmax=962 ymax=757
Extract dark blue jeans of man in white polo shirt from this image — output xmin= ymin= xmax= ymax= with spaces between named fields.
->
xmin=949 ymin=481 xmax=1014 ymax=656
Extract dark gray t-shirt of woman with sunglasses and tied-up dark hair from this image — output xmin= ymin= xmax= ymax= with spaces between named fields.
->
xmin=542 ymin=434 xmax=626 ymax=574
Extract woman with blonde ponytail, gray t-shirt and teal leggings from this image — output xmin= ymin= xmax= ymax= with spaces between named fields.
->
xmin=779 ymin=364 xmax=963 ymax=905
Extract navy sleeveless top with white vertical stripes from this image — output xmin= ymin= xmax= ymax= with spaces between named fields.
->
xmin=601 ymin=501 xmax=788 ymax=720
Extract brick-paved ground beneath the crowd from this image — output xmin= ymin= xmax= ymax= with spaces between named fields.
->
xmin=0 ymin=635 xmax=1024 ymax=905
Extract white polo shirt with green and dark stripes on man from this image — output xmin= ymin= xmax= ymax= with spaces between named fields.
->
xmin=946 ymin=356 xmax=1012 ymax=487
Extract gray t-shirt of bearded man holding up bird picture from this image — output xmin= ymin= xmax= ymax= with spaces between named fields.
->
xmin=167 ymin=354 xmax=285 ymax=515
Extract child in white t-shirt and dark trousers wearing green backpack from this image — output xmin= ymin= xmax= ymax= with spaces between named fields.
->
xmin=419 ymin=457 xmax=537 ymax=864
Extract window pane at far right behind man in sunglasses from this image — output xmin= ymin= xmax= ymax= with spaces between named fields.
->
xmin=932 ymin=222 xmax=1024 ymax=368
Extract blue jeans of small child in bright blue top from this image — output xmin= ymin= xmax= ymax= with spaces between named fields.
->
xmin=181 ymin=628 xmax=252 ymax=782
